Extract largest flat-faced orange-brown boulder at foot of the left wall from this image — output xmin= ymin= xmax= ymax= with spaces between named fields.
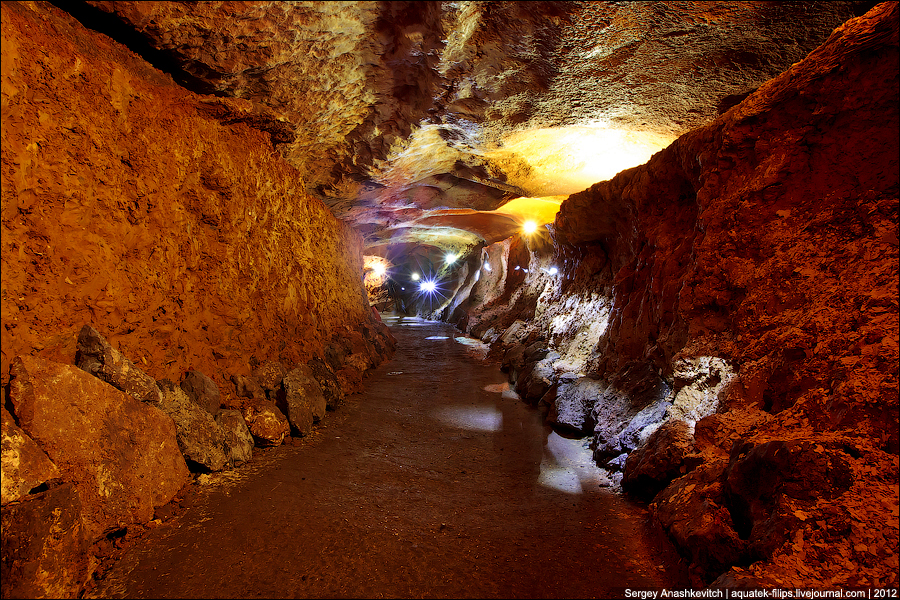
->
xmin=10 ymin=356 xmax=189 ymax=540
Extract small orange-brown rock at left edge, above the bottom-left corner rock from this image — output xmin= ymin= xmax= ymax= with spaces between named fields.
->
xmin=0 ymin=408 xmax=59 ymax=505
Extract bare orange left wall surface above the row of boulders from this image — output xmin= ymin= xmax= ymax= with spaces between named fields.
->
xmin=0 ymin=3 xmax=373 ymax=393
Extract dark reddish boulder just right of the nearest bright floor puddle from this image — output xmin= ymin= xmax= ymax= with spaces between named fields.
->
xmin=622 ymin=420 xmax=694 ymax=500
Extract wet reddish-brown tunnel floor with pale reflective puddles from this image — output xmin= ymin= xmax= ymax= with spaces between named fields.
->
xmin=90 ymin=317 xmax=684 ymax=598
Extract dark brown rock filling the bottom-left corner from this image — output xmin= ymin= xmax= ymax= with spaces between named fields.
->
xmin=0 ymin=483 xmax=90 ymax=598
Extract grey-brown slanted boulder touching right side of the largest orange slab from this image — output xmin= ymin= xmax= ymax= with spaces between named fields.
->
xmin=159 ymin=383 xmax=229 ymax=471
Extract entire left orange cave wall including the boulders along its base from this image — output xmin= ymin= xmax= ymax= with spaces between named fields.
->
xmin=0 ymin=2 xmax=393 ymax=597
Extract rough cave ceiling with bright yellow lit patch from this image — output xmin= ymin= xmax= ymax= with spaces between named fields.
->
xmin=86 ymin=2 xmax=873 ymax=256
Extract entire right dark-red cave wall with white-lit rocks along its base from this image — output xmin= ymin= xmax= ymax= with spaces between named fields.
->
xmin=455 ymin=3 xmax=898 ymax=587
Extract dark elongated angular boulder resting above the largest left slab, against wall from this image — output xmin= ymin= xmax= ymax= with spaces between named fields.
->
xmin=75 ymin=325 xmax=160 ymax=403
